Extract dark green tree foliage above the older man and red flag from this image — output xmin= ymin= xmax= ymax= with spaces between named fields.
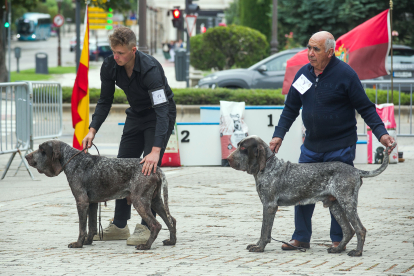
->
xmin=278 ymin=0 xmax=414 ymax=46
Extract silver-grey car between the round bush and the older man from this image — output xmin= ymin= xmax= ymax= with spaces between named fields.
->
xmin=198 ymin=48 xmax=305 ymax=89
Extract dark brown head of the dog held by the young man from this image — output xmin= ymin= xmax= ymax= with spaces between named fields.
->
xmin=25 ymin=140 xmax=62 ymax=177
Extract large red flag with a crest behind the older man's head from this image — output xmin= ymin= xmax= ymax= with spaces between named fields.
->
xmin=282 ymin=10 xmax=391 ymax=95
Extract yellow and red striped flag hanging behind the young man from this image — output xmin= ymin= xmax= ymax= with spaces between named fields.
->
xmin=71 ymin=6 xmax=89 ymax=150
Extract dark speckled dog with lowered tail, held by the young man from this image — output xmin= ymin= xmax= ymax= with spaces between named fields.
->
xmin=26 ymin=140 xmax=177 ymax=250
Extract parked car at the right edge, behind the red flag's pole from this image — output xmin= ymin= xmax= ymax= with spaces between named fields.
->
xmin=367 ymin=45 xmax=414 ymax=92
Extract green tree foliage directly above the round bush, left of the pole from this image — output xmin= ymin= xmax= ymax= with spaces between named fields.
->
xmin=238 ymin=0 xmax=273 ymax=42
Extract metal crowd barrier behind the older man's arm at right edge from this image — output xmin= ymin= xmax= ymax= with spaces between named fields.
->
xmin=358 ymin=78 xmax=414 ymax=137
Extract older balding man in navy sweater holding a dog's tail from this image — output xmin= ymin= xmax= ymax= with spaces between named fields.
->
xmin=270 ymin=31 xmax=394 ymax=250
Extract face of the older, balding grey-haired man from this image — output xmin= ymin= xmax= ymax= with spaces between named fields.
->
xmin=308 ymin=36 xmax=333 ymax=70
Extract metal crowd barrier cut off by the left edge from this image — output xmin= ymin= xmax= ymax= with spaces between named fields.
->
xmin=0 ymin=82 xmax=34 ymax=179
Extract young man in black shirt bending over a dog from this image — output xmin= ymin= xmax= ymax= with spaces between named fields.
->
xmin=82 ymin=27 xmax=176 ymax=245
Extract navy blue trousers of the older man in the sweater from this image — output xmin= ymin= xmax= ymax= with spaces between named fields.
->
xmin=292 ymin=145 xmax=356 ymax=242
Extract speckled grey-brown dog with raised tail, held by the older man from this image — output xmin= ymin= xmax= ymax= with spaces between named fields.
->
xmin=227 ymin=136 xmax=388 ymax=256
